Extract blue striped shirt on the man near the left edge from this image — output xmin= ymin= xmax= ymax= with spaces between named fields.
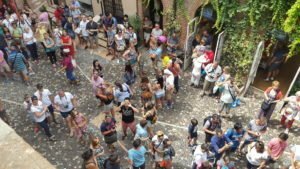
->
xmin=8 ymin=51 xmax=26 ymax=72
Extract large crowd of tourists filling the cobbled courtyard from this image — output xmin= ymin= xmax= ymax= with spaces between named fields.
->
xmin=0 ymin=0 xmax=300 ymax=169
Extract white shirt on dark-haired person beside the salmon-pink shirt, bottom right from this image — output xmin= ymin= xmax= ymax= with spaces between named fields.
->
xmin=246 ymin=147 xmax=269 ymax=166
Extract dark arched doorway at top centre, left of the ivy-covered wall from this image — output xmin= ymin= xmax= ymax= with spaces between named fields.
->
xmin=143 ymin=0 xmax=163 ymax=27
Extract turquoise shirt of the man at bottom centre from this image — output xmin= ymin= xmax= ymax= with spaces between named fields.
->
xmin=128 ymin=146 xmax=147 ymax=167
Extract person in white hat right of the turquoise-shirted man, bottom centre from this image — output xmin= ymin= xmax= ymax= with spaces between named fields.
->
xmin=151 ymin=130 xmax=168 ymax=167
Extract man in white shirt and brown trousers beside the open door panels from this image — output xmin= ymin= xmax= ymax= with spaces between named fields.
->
xmin=201 ymin=62 xmax=222 ymax=97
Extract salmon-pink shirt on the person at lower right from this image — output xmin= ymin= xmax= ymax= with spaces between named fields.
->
xmin=268 ymin=138 xmax=287 ymax=158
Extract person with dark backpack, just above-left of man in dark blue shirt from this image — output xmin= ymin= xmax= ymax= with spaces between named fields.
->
xmin=203 ymin=114 xmax=222 ymax=143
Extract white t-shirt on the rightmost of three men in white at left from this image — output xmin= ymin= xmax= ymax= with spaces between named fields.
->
xmin=54 ymin=92 xmax=74 ymax=112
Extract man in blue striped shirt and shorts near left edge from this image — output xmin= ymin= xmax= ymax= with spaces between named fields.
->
xmin=8 ymin=44 xmax=29 ymax=85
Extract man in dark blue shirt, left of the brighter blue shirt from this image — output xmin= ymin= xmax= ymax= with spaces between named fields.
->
xmin=210 ymin=128 xmax=233 ymax=161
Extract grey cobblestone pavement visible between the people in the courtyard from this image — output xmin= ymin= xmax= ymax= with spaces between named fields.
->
xmin=0 ymin=46 xmax=300 ymax=169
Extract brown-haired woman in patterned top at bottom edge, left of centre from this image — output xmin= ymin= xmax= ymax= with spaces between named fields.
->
xmin=90 ymin=137 xmax=105 ymax=169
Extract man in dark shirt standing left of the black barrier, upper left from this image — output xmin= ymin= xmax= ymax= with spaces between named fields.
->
xmin=86 ymin=16 xmax=98 ymax=48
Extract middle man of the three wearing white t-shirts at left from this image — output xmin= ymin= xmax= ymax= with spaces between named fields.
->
xmin=34 ymin=83 xmax=58 ymax=124
